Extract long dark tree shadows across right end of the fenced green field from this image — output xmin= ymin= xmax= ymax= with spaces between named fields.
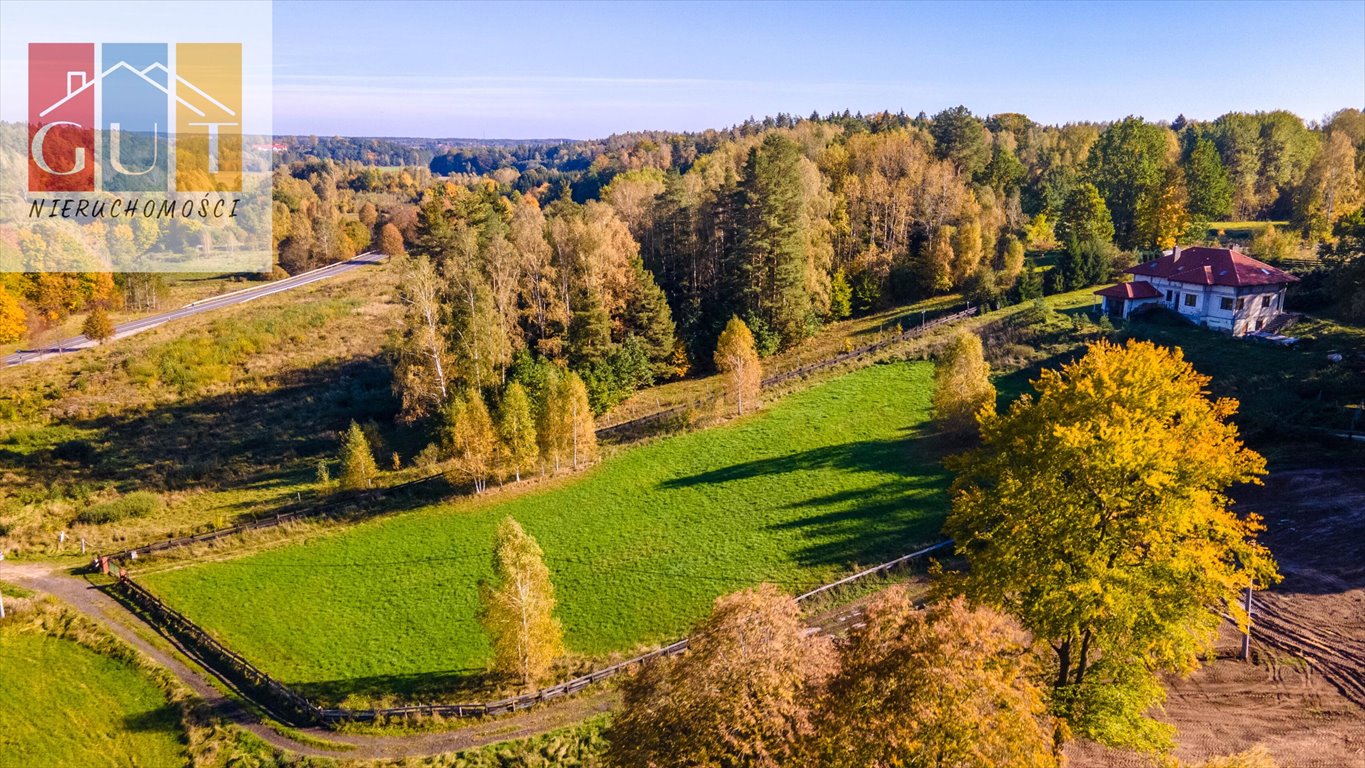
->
xmin=661 ymin=424 xmax=949 ymax=567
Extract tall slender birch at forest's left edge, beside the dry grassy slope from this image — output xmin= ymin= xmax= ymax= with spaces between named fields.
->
xmin=393 ymin=256 xmax=450 ymax=420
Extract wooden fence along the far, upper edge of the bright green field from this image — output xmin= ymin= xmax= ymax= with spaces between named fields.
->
xmin=90 ymin=306 xmax=977 ymax=570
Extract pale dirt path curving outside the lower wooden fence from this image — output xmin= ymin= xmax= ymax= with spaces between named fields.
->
xmin=3 ymin=561 xmax=618 ymax=760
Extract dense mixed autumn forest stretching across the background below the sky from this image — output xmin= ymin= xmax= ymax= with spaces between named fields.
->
xmin=0 ymin=106 xmax=1365 ymax=411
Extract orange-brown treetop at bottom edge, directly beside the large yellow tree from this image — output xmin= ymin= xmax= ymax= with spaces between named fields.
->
xmin=805 ymin=585 xmax=1058 ymax=768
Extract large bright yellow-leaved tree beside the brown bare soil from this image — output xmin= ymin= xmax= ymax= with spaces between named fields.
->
xmin=945 ymin=341 xmax=1278 ymax=750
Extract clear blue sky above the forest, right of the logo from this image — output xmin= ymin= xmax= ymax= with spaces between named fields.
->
xmin=274 ymin=0 xmax=1365 ymax=138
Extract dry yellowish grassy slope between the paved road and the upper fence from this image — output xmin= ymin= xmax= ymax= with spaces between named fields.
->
xmin=0 ymin=267 xmax=396 ymax=554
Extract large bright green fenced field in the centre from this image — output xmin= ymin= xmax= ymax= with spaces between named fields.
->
xmin=143 ymin=363 xmax=946 ymax=700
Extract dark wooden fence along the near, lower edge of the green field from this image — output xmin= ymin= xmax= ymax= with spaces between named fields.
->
xmin=117 ymin=539 xmax=953 ymax=727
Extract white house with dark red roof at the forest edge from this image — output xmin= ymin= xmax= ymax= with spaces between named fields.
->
xmin=1095 ymin=246 xmax=1298 ymax=336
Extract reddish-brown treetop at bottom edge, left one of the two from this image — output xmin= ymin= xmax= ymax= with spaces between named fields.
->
xmin=606 ymin=584 xmax=835 ymax=768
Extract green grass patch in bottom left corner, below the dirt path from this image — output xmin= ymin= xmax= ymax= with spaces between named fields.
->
xmin=0 ymin=633 xmax=187 ymax=768
